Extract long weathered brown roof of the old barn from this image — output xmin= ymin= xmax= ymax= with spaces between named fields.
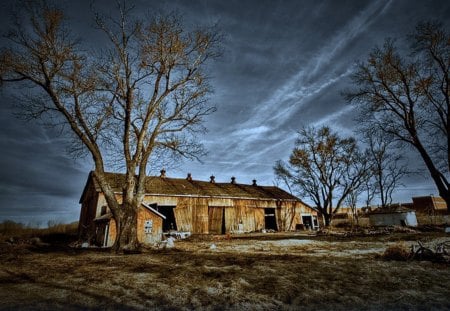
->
xmin=80 ymin=172 xmax=306 ymax=205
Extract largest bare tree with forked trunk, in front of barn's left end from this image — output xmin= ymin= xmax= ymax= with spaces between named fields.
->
xmin=0 ymin=2 xmax=219 ymax=251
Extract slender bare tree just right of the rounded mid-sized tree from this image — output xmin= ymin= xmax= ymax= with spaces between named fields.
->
xmin=365 ymin=129 xmax=410 ymax=207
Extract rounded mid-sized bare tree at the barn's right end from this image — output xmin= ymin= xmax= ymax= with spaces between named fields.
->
xmin=274 ymin=127 xmax=368 ymax=226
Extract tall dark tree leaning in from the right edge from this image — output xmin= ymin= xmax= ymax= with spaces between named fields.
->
xmin=346 ymin=22 xmax=450 ymax=211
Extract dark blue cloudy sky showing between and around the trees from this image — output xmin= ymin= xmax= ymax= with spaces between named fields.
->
xmin=0 ymin=0 xmax=450 ymax=226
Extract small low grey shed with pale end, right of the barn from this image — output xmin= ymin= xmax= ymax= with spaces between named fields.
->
xmin=369 ymin=205 xmax=417 ymax=227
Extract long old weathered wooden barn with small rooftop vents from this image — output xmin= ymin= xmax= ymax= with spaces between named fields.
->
xmin=79 ymin=171 xmax=317 ymax=246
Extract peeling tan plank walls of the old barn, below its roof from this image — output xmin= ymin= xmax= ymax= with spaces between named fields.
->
xmin=80 ymin=190 xmax=317 ymax=246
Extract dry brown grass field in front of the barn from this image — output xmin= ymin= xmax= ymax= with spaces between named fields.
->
xmin=0 ymin=232 xmax=450 ymax=310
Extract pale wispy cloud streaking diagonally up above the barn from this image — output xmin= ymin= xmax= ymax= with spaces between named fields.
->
xmin=208 ymin=1 xmax=390 ymax=176
